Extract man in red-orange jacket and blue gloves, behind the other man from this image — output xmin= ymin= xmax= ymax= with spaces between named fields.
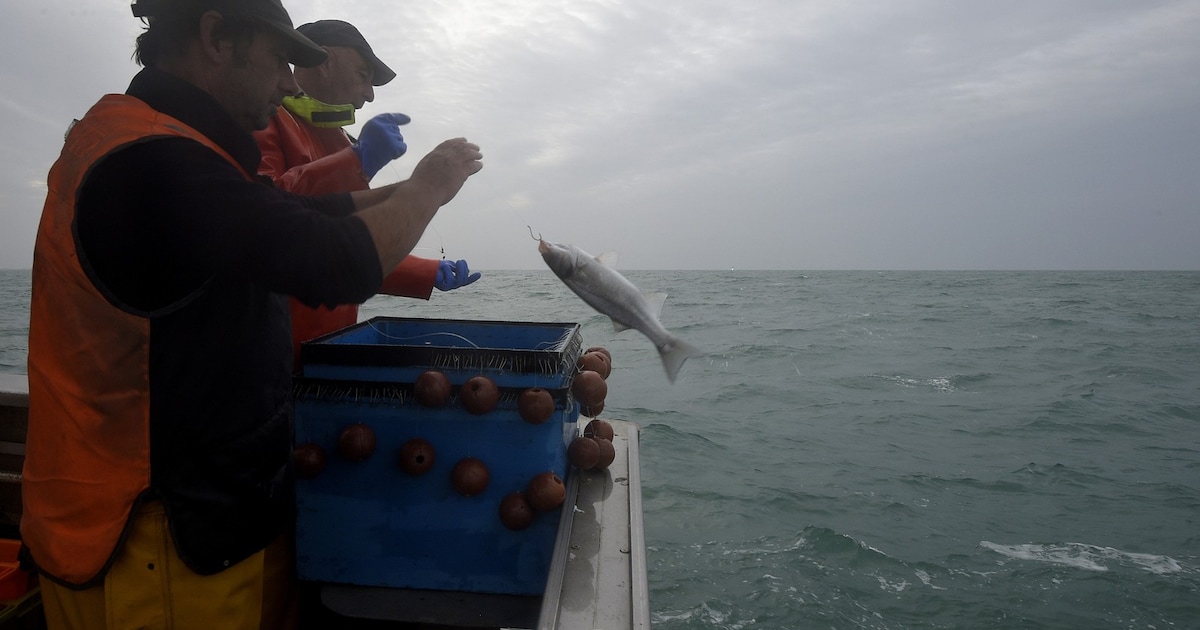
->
xmin=254 ymin=19 xmax=480 ymax=361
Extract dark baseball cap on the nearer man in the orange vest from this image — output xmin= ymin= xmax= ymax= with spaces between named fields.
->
xmin=130 ymin=0 xmax=329 ymax=67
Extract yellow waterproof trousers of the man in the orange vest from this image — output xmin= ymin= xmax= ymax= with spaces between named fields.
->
xmin=41 ymin=503 xmax=298 ymax=630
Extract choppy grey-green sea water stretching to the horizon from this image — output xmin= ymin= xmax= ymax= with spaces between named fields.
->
xmin=0 ymin=270 xmax=1200 ymax=629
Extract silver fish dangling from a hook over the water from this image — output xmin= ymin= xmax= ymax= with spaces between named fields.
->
xmin=538 ymin=238 xmax=704 ymax=383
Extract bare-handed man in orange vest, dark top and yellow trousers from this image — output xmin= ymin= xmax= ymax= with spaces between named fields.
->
xmin=20 ymin=0 xmax=482 ymax=630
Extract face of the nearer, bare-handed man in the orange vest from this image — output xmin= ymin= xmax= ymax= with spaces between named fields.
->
xmin=215 ymin=29 xmax=300 ymax=131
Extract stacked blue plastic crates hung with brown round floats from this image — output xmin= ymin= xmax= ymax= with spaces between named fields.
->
xmin=295 ymin=318 xmax=581 ymax=595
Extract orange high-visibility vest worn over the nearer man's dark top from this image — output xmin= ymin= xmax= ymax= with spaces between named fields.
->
xmin=20 ymin=95 xmax=251 ymax=586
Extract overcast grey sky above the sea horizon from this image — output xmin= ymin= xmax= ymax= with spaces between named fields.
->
xmin=0 ymin=0 xmax=1200 ymax=270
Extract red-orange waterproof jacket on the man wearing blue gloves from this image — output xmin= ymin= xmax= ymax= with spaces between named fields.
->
xmin=254 ymin=107 xmax=439 ymax=361
